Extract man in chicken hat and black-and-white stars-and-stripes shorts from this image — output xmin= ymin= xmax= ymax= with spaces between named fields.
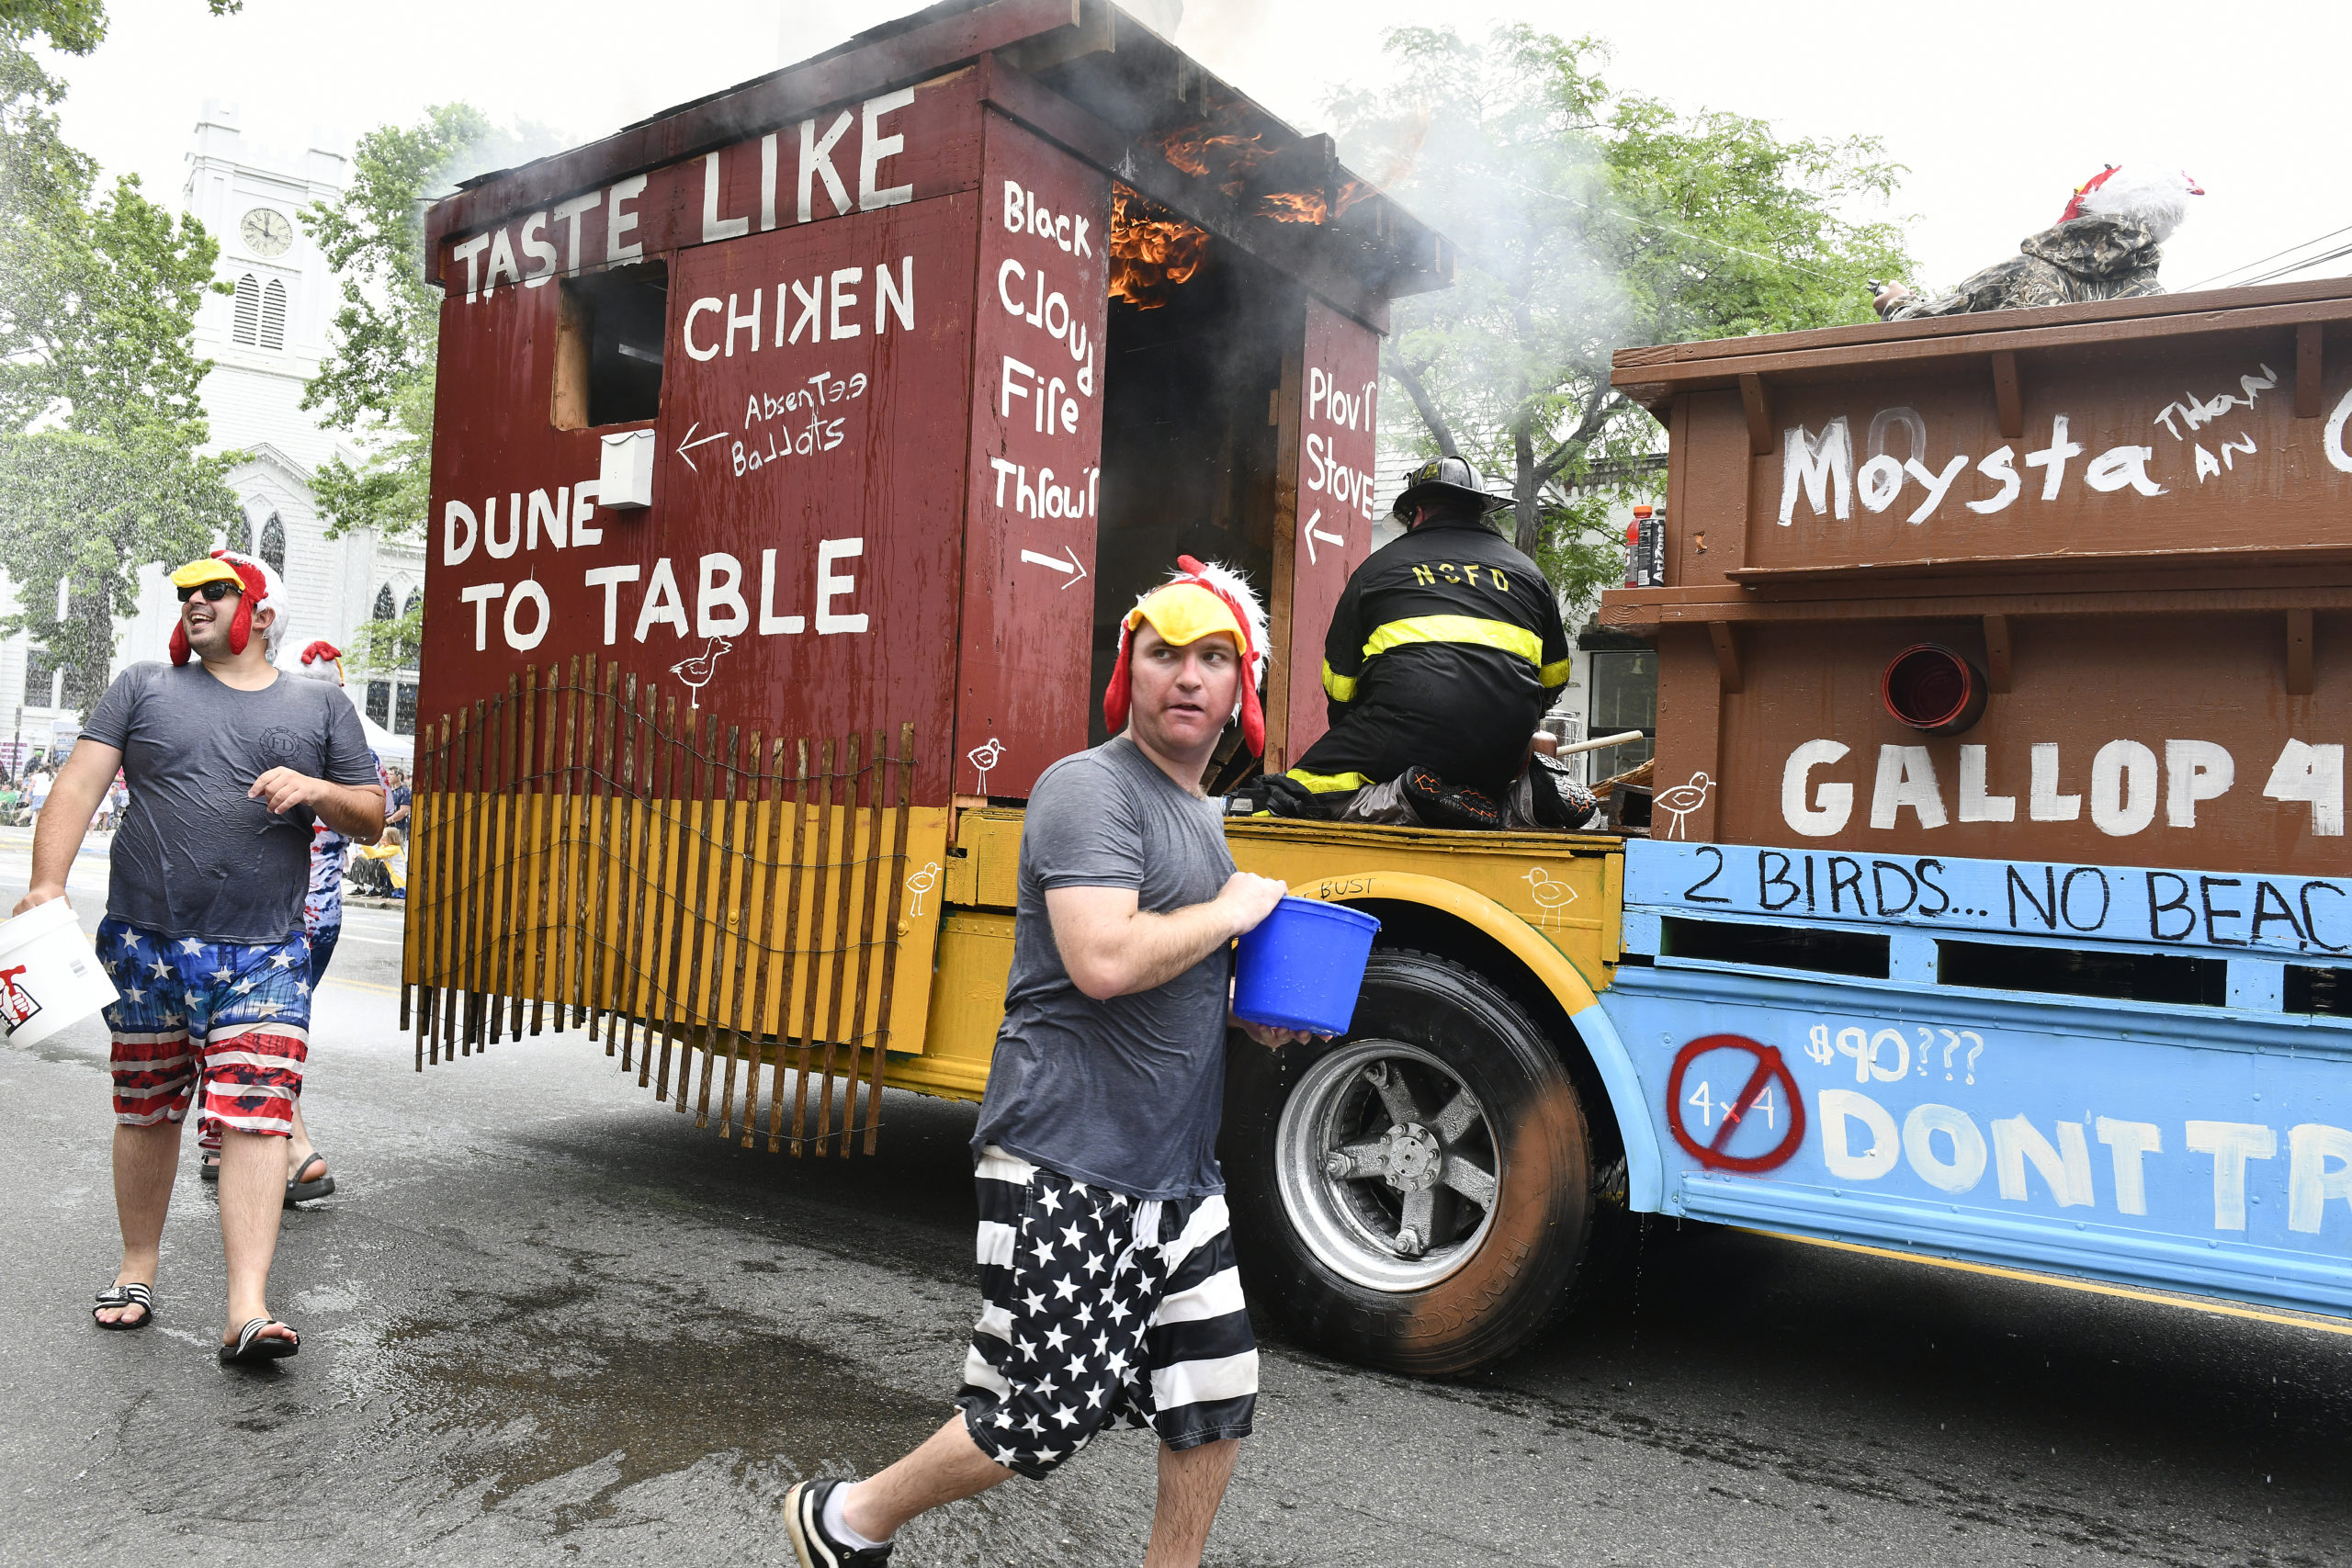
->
xmin=786 ymin=558 xmax=1298 ymax=1568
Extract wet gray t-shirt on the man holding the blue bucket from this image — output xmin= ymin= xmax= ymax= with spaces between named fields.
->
xmin=971 ymin=739 xmax=1232 ymax=1199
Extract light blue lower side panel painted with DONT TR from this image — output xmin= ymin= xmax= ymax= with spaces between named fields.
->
xmin=1601 ymin=964 xmax=2352 ymax=1312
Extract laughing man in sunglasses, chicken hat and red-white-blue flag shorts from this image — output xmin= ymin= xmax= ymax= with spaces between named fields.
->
xmin=17 ymin=550 xmax=383 ymax=1363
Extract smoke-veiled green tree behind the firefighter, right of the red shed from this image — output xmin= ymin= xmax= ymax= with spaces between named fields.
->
xmin=1334 ymin=24 xmax=1910 ymax=604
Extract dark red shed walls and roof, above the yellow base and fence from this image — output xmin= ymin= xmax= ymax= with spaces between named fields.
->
xmin=419 ymin=0 xmax=1452 ymax=807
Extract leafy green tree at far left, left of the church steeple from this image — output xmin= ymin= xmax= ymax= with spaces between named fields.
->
xmin=0 ymin=0 xmax=238 ymax=707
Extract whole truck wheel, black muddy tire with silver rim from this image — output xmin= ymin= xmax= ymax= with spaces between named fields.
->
xmin=1226 ymin=950 xmax=1592 ymax=1375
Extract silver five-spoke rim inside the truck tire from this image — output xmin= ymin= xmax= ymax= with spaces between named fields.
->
xmin=1275 ymin=1039 xmax=1503 ymax=1293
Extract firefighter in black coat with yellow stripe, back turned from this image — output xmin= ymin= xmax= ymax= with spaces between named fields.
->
xmin=1253 ymin=458 xmax=1588 ymax=828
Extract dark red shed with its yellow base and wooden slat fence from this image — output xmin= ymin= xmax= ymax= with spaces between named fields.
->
xmin=402 ymin=0 xmax=1452 ymax=1128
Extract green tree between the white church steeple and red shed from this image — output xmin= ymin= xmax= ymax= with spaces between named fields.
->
xmin=301 ymin=104 xmax=560 ymax=670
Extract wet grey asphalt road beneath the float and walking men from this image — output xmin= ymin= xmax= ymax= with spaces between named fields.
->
xmin=0 ymin=832 xmax=2352 ymax=1568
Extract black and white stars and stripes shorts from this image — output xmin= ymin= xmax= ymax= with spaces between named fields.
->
xmin=955 ymin=1145 xmax=1259 ymax=1479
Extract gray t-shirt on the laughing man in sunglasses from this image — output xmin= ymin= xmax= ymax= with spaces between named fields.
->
xmin=83 ymin=663 xmax=377 ymax=942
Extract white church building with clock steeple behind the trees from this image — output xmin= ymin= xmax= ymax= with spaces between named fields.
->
xmin=0 ymin=101 xmax=424 ymax=761
